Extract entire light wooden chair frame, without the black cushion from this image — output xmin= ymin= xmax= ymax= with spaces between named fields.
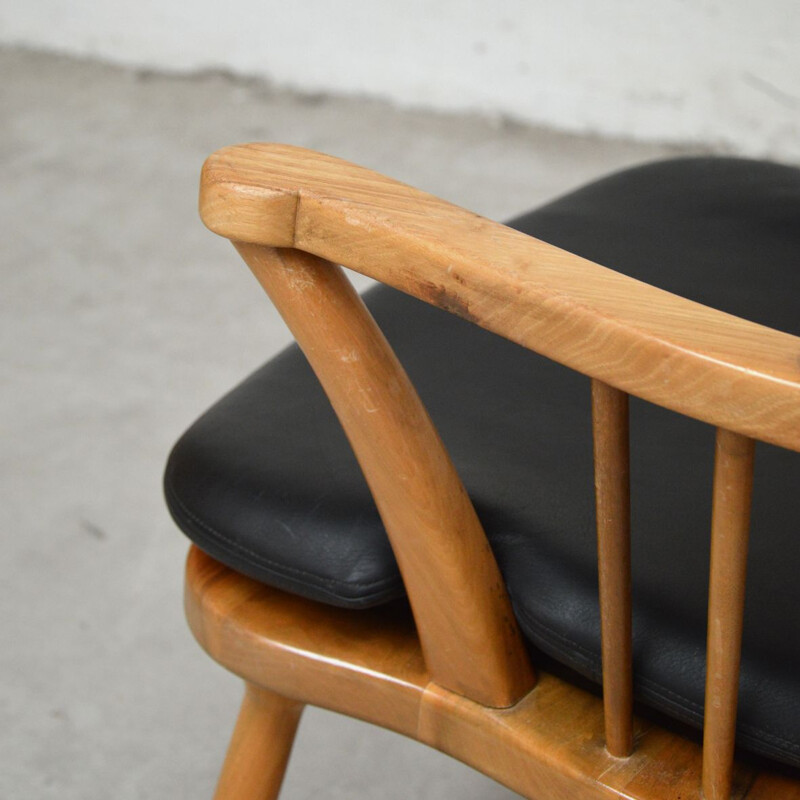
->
xmin=186 ymin=145 xmax=800 ymax=800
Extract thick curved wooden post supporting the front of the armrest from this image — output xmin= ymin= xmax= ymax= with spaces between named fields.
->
xmin=228 ymin=243 xmax=533 ymax=706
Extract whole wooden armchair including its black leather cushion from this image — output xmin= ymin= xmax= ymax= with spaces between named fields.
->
xmin=166 ymin=145 xmax=800 ymax=800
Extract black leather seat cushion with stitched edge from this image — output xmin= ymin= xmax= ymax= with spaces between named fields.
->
xmin=165 ymin=159 xmax=800 ymax=766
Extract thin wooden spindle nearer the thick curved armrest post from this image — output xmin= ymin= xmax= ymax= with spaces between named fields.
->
xmin=592 ymin=380 xmax=633 ymax=757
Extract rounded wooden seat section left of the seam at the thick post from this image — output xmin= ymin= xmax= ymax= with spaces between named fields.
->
xmin=184 ymin=546 xmax=430 ymax=737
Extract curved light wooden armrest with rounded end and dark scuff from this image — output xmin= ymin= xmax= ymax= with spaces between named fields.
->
xmin=200 ymin=144 xmax=800 ymax=450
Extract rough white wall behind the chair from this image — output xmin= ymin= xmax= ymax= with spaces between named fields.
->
xmin=0 ymin=0 xmax=800 ymax=160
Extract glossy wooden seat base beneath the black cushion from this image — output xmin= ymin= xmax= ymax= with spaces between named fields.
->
xmin=186 ymin=547 xmax=800 ymax=800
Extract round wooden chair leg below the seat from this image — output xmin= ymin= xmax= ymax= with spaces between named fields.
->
xmin=214 ymin=683 xmax=303 ymax=800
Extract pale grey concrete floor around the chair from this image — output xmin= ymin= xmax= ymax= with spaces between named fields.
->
xmin=0 ymin=50 xmax=708 ymax=800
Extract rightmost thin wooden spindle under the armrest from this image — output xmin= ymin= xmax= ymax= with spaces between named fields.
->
xmin=703 ymin=428 xmax=755 ymax=800
